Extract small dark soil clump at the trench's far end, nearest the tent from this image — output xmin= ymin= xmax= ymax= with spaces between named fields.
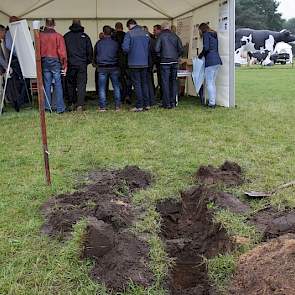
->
xmin=195 ymin=161 xmax=244 ymax=186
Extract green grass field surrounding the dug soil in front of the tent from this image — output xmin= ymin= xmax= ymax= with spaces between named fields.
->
xmin=0 ymin=67 xmax=295 ymax=295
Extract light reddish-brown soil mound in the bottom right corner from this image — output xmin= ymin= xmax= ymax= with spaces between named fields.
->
xmin=229 ymin=235 xmax=295 ymax=295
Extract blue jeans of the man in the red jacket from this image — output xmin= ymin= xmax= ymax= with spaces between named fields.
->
xmin=42 ymin=57 xmax=66 ymax=113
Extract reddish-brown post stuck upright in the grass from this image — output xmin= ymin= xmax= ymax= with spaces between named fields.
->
xmin=34 ymin=29 xmax=51 ymax=185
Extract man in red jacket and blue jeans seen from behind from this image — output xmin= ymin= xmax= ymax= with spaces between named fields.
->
xmin=40 ymin=18 xmax=67 ymax=114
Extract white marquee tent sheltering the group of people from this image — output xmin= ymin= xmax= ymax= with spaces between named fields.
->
xmin=0 ymin=0 xmax=235 ymax=107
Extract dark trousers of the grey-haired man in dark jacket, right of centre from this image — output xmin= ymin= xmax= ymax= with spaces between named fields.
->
xmin=161 ymin=64 xmax=178 ymax=108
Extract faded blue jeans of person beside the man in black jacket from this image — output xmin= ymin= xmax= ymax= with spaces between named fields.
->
xmin=98 ymin=70 xmax=121 ymax=109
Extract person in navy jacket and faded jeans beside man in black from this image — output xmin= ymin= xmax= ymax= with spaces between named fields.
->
xmin=94 ymin=26 xmax=121 ymax=112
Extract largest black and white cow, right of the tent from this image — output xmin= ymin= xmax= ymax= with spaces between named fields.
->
xmin=235 ymin=29 xmax=295 ymax=65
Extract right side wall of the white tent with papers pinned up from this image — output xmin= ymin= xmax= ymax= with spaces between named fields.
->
xmin=173 ymin=0 xmax=235 ymax=107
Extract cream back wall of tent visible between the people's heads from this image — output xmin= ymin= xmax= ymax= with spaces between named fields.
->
xmin=29 ymin=19 xmax=168 ymax=91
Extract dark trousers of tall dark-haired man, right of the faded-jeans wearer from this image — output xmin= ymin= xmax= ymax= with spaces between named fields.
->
xmin=130 ymin=68 xmax=150 ymax=109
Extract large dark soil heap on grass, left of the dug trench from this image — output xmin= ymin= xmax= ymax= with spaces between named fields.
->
xmin=42 ymin=166 xmax=153 ymax=291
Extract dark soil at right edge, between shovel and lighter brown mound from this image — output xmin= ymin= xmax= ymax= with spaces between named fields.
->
xmin=249 ymin=207 xmax=295 ymax=241
